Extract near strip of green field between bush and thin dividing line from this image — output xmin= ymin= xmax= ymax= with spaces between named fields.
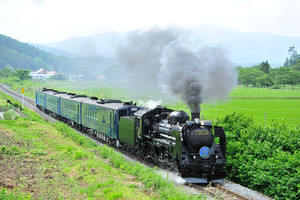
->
xmin=201 ymin=99 xmax=300 ymax=127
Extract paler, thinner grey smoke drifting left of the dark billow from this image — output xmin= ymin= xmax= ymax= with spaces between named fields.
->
xmin=117 ymin=28 xmax=178 ymax=93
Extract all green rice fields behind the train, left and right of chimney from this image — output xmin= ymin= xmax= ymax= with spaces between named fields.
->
xmin=14 ymin=82 xmax=300 ymax=127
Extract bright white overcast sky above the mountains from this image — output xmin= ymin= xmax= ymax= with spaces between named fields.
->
xmin=0 ymin=0 xmax=300 ymax=43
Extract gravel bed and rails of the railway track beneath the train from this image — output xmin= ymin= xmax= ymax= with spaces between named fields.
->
xmin=0 ymin=84 xmax=271 ymax=200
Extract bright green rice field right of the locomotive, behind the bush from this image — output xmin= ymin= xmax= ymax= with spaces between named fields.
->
xmin=170 ymin=86 xmax=300 ymax=127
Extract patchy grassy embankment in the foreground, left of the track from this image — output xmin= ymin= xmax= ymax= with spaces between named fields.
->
xmin=0 ymin=93 xmax=204 ymax=199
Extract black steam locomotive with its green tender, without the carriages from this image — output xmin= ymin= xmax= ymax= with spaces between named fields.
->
xmin=119 ymin=106 xmax=226 ymax=183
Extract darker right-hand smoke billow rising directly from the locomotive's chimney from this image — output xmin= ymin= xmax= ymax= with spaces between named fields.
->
xmin=159 ymin=40 xmax=235 ymax=112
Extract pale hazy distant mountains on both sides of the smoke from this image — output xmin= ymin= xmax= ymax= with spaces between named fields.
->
xmin=43 ymin=25 xmax=300 ymax=67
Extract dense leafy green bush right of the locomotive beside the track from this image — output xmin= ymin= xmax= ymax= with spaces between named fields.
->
xmin=217 ymin=113 xmax=300 ymax=199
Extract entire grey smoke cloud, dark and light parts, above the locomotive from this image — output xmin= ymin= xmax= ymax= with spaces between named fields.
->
xmin=118 ymin=28 xmax=236 ymax=112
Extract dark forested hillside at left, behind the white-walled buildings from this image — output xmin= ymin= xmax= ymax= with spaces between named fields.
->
xmin=0 ymin=34 xmax=75 ymax=73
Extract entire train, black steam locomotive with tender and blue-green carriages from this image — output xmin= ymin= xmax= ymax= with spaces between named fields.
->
xmin=36 ymin=88 xmax=226 ymax=183
